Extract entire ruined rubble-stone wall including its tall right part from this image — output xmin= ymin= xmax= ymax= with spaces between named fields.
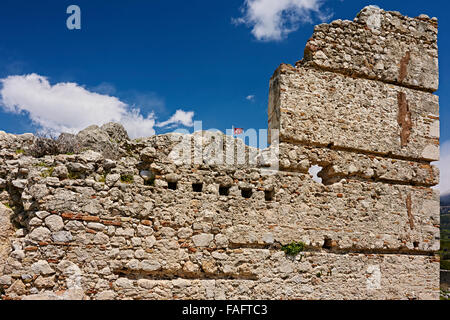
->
xmin=0 ymin=6 xmax=440 ymax=299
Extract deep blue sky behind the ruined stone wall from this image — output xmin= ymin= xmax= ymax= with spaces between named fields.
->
xmin=0 ymin=0 xmax=450 ymax=191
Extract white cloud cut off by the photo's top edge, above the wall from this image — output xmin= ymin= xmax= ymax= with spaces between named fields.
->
xmin=233 ymin=0 xmax=331 ymax=41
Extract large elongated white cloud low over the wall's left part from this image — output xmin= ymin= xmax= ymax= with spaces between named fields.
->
xmin=0 ymin=74 xmax=194 ymax=138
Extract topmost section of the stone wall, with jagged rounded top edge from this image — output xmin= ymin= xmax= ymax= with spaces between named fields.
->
xmin=300 ymin=6 xmax=439 ymax=92
